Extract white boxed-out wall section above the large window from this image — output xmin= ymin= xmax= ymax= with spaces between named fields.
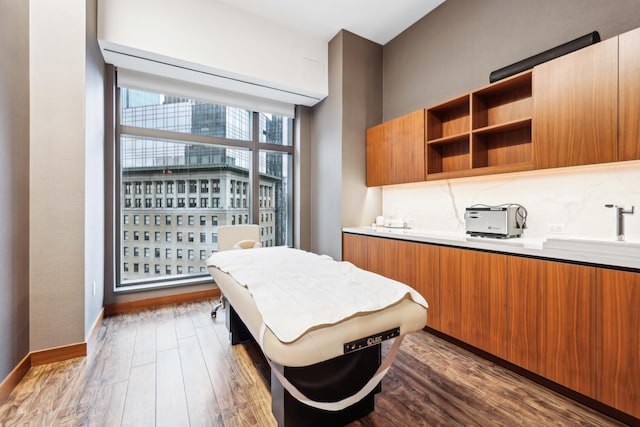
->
xmin=98 ymin=0 xmax=328 ymax=105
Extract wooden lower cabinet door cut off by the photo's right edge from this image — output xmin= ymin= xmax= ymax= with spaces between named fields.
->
xmin=597 ymin=269 xmax=640 ymax=418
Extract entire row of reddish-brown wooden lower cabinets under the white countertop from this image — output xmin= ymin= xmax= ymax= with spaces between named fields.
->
xmin=343 ymin=233 xmax=640 ymax=418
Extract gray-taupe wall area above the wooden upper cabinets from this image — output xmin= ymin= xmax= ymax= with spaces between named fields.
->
xmin=383 ymin=0 xmax=640 ymax=120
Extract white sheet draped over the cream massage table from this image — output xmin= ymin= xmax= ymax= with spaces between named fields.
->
xmin=207 ymin=247 xmax=428 ymax=343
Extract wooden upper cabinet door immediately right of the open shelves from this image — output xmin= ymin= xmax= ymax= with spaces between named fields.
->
xmin=532 ymin=37 xmax=618 ymax=168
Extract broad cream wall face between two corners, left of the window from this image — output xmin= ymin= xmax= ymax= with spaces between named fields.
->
xmin=29 ymin=0 xmax=86 ymax=351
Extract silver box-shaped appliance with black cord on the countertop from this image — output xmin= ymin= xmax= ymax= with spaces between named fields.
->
xmin=464 ymin=204 xmax=527 ymax=239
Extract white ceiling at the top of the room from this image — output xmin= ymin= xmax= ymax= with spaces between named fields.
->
xmin=218 ymin=0 xmax=444 ymax=45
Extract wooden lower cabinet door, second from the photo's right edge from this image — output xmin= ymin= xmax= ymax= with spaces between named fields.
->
xmin=506 ymin=257 xmax=596 ymax=398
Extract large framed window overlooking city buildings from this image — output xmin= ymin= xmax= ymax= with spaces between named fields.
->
xmin=115 ymin=87 xmax=293 ymax=289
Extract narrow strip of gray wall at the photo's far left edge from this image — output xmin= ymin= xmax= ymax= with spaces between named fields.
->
xmin=0 ymin=0 xmax=29 ymax=381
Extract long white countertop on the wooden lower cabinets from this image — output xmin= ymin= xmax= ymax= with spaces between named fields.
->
xmin=343 ymin=227 xmax=640 ymax=270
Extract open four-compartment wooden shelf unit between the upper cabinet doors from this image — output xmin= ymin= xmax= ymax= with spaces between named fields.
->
xmin=376 ymin=70 xmax=534 ymax=182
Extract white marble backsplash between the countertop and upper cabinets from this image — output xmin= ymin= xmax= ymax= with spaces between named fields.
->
xmin=380 ymin=161 xmax=640 ymax=242
